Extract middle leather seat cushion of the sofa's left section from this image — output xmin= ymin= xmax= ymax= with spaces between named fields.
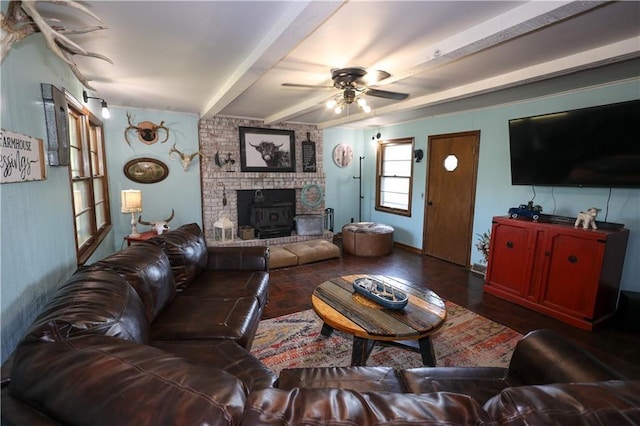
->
xmin=151 ymin=295 xmax=261 ymax=349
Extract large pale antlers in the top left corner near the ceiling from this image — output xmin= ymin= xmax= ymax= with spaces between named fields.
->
xmin=0 ymin=0 xmax=113 ymax=90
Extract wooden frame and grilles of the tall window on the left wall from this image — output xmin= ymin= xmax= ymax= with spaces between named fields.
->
xmin=64 ymin=90 xmax=113 ymax=265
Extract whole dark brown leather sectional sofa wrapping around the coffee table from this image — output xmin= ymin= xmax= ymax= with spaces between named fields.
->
xmin=1 ymin=224 xmax=640 ymax=425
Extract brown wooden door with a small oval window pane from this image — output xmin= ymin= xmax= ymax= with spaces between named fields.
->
xmin=422 ymin=130 xmax=480 ymax=266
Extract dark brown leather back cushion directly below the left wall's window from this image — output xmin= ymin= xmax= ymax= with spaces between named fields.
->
xmin=25 ymin=266 xmax=149 ymax=343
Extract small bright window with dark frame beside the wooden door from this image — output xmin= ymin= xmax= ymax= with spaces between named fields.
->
xmin=376 ymin=138 xmax=413 ymax=216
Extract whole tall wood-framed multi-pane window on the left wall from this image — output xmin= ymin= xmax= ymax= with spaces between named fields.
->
xmin=67 ymin=94 xmax=111 ymax=265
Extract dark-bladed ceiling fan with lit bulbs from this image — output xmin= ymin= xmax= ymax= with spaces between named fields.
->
xmin=282 ymin=67 xmax=409 ymax=114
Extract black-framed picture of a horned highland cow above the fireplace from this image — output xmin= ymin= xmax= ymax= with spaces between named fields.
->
xmin=240 ymin=127 xmax=296 ymax=172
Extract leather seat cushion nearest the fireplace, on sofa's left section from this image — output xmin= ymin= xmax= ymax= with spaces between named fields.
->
xmin=180 ymin=269 xmax=269 ymax=307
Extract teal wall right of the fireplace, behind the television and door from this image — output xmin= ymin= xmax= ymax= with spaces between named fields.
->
xmin=324 ymin=79 xmax=640 ymax=291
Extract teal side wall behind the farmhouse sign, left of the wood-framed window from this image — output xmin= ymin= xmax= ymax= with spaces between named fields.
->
xmin=0 ymin=35 xmax=90 ymax=361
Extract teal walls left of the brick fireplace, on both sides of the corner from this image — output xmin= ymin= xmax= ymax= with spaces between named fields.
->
xmin=0 ymin=35 xmax=202 ymax=362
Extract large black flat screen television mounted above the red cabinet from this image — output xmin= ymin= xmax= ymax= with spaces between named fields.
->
xmin=509 ymin=100 xmax=640 ymax=188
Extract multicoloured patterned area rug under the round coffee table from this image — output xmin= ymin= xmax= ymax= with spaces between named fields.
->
xmin=251 ymin=302 xmax=522 ymax=374
